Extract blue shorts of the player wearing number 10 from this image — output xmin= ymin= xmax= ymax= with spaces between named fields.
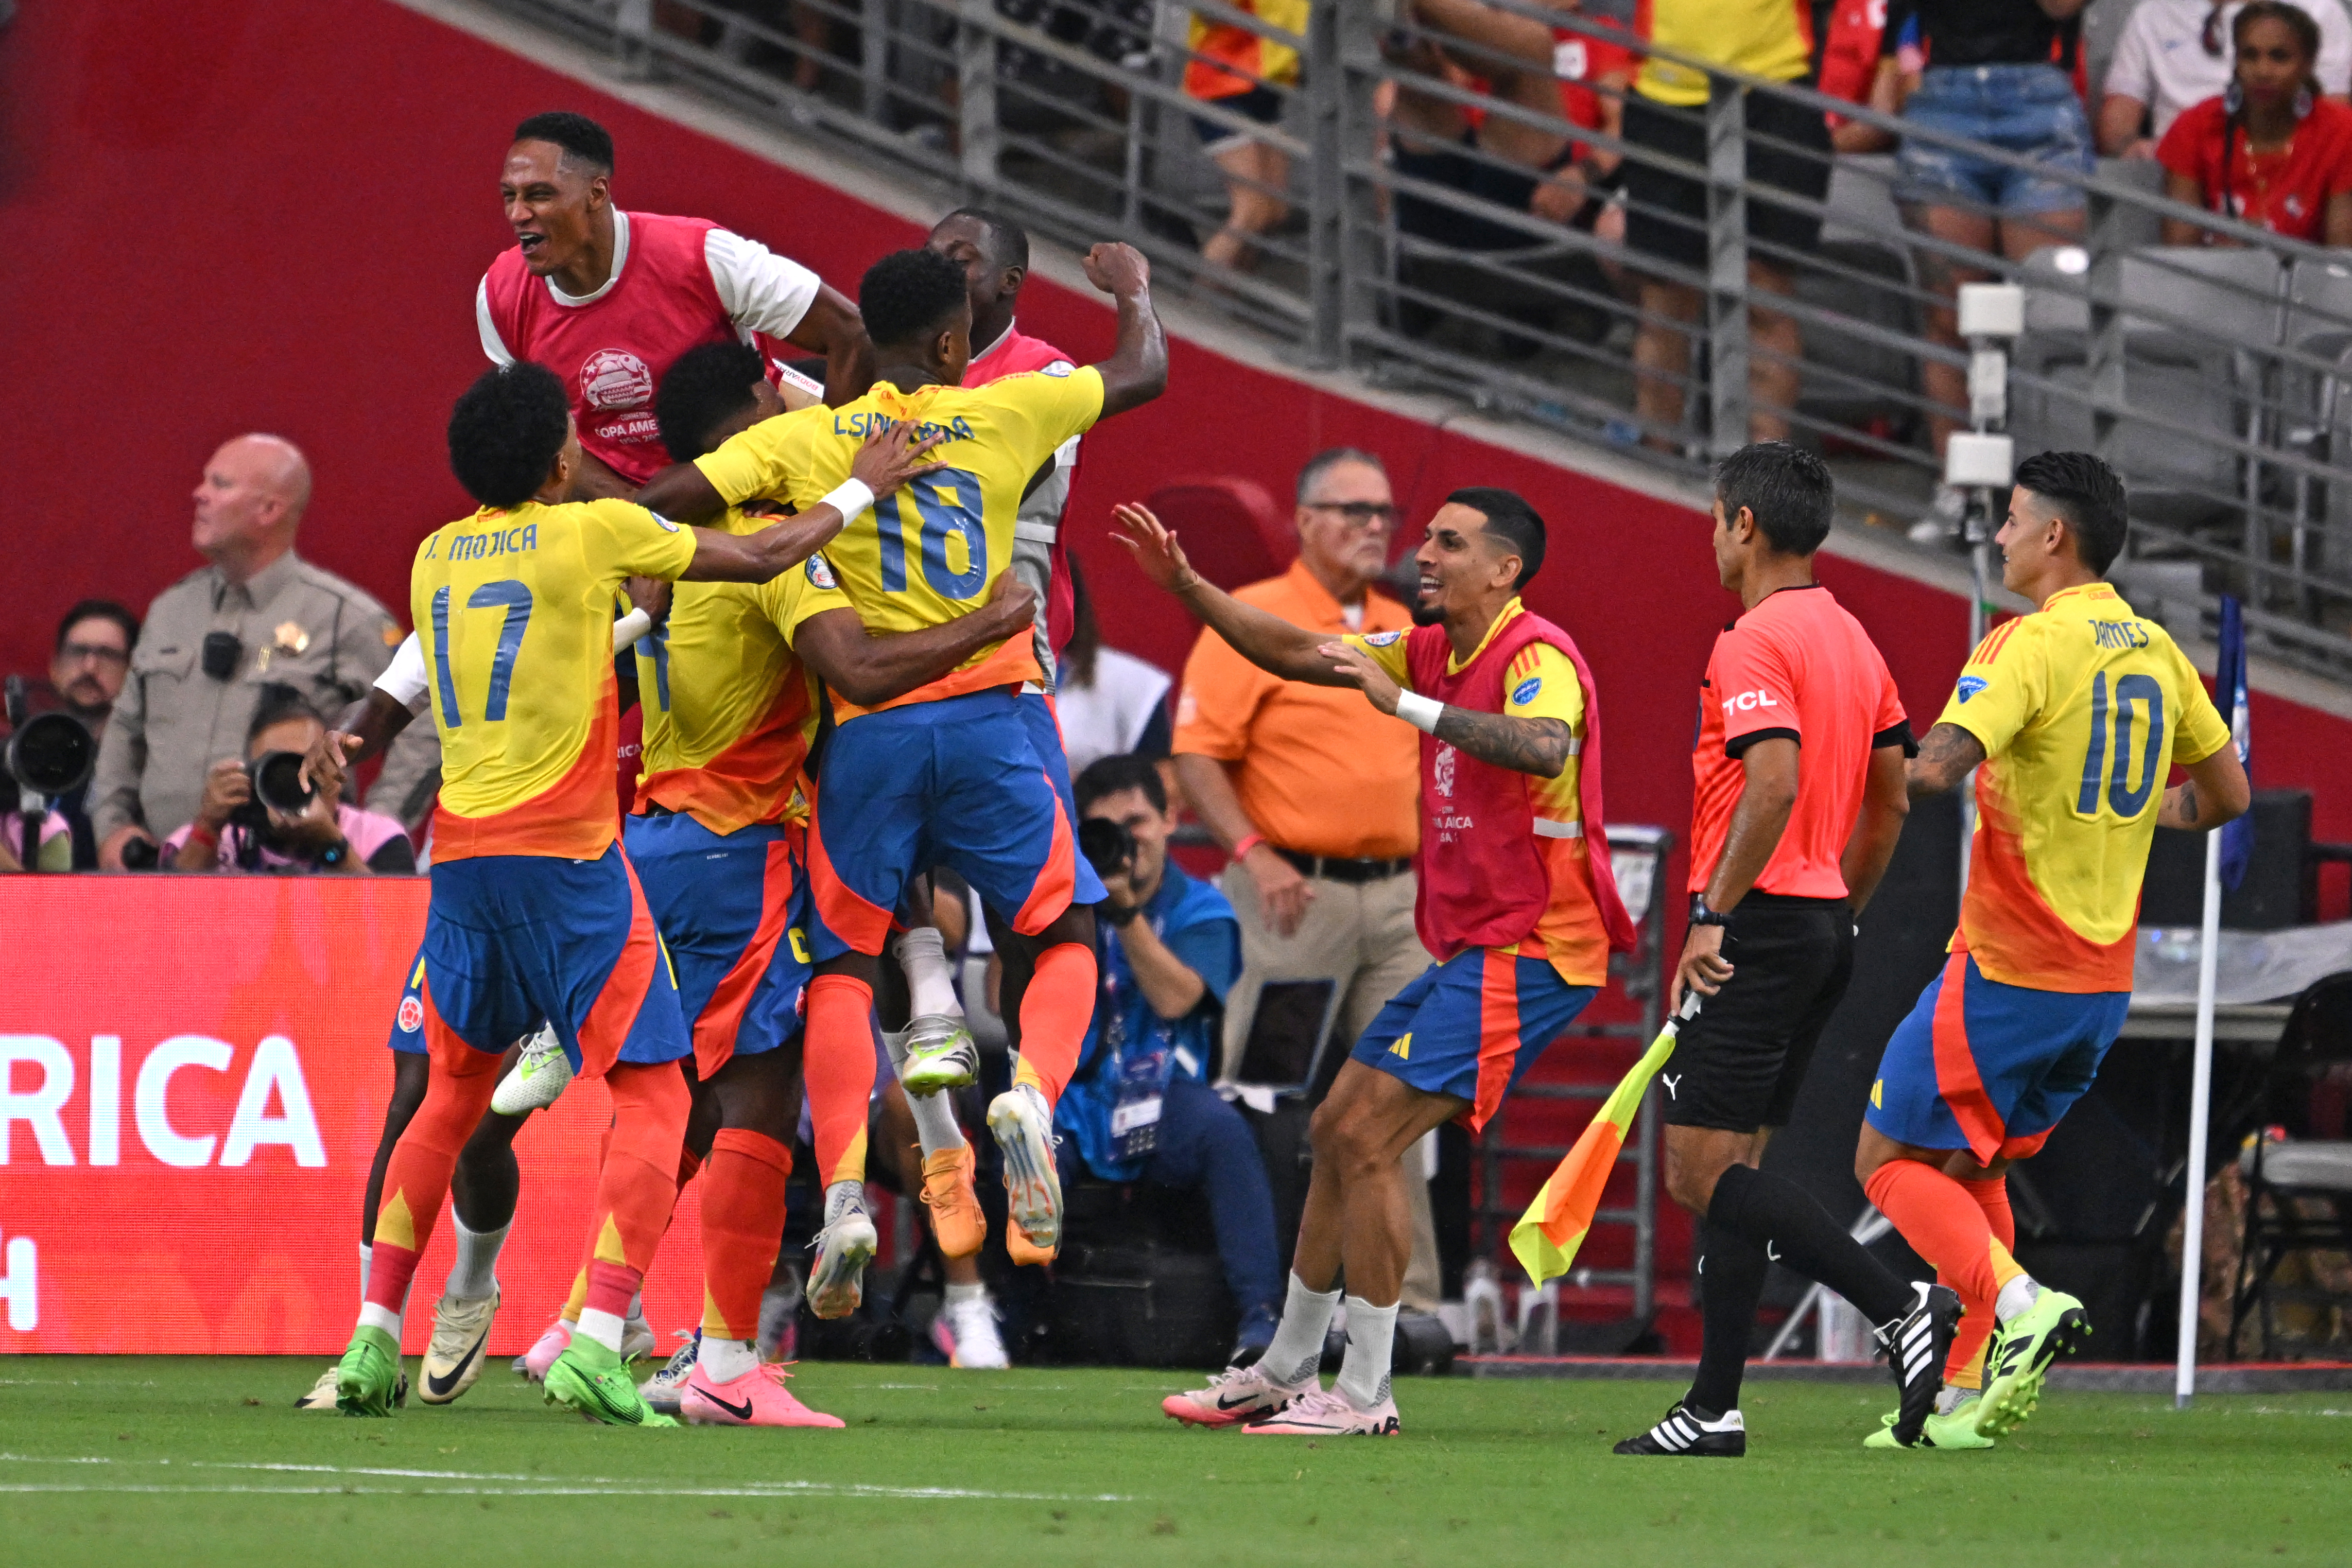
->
xmin=1863 ymin=952 xmax=2131 ymax=1164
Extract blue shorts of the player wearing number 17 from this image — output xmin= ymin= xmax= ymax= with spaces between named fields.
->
xmin=419 ymin=844 xmax=691 ymax=1077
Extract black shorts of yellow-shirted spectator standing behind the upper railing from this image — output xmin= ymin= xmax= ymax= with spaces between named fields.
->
xmin=1623 ymin=92 xmax=1830 ymax=276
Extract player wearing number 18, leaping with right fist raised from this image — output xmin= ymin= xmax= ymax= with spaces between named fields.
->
xmin=639 ymin=245 xmax=1167 ymax=1262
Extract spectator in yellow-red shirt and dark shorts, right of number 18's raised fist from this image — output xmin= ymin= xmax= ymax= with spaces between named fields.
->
xmin=1183 ymin=0 xmax=1308 ymax=273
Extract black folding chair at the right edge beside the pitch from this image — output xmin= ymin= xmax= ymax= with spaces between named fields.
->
xmin=2229 ymin=973 xmax=2352 ymax=1361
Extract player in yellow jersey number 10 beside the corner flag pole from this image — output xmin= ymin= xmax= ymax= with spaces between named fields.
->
xmin=1854 ymin=451 xmax=2249 ymax=1448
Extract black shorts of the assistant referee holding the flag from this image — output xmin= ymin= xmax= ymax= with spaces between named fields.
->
xmin=1658 ymin=893 xmax=1854 ymax=1133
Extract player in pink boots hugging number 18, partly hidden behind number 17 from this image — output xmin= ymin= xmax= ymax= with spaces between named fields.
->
xmin=626 ymin=343 xmax=1035 ymax=1427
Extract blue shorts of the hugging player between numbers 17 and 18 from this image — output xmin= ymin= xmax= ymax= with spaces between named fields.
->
xmin=626 ymin=811 xmax=809 ymax=1079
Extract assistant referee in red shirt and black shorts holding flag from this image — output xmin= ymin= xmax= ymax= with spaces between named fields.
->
xmin=1616 ymin=442 xmax=1959 ymax=1457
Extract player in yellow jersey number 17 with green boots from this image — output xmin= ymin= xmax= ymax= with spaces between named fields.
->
xmin=336 ymin=362 xmax=929 ymax=1424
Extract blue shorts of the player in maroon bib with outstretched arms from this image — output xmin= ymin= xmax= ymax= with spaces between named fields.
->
xmin=1350 ymin=947 xmax=1595 ymax=1136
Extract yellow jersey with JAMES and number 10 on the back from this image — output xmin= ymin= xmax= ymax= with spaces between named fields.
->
xmin=1935 ymin=583 xmax=2229 ymax=992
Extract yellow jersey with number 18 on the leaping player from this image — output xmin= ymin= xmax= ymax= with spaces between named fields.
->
xmin=694 ymin=364 xmax=1103 ymax=717
